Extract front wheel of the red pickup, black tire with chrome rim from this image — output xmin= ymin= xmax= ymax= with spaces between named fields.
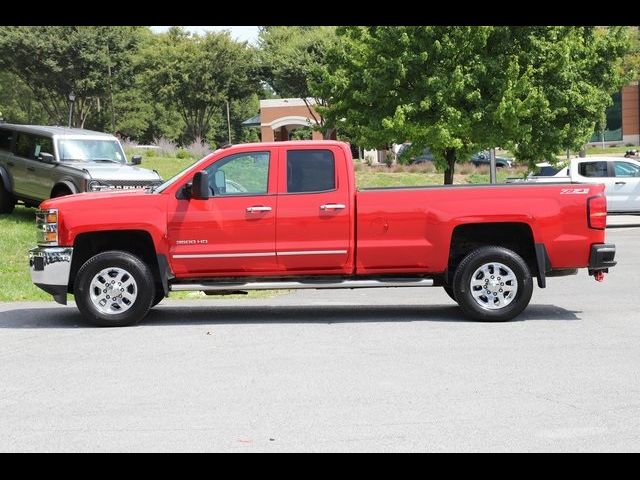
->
xmin=73 ymin=250 xmax=156 ymax=327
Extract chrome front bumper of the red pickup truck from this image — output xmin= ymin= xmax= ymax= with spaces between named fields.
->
xmin=29 ymin=247 xmax=73 ymax=305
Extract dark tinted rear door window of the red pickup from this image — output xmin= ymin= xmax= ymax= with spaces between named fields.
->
xmin=287 ymin=150 xmax=336 ymax=193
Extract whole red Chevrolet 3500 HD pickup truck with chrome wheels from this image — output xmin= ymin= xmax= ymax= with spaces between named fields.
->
xmin=30 ymin=141 xmax=616 ymax=326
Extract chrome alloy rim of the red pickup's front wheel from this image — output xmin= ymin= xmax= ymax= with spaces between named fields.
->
xmin=90 ymin=267 xmax=138 ymax=315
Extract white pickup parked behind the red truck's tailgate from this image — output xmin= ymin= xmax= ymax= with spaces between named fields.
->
xmin=510 ymin=157 xmax=640 ymax=213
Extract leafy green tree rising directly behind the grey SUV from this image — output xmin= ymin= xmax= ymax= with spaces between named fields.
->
xmin=0 ymin=26 xmax=144 ymax=127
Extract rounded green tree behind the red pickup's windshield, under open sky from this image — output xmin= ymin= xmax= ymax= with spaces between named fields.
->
xmin=143 ymin=27 xmax=260 ymax=140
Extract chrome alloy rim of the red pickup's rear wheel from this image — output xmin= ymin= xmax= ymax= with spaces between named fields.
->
xmin=469 ymin=262 xmax=518 ymax=310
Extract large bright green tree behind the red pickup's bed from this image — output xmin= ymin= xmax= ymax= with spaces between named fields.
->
xmin=319 ymin=26 xmax=627 ymax=184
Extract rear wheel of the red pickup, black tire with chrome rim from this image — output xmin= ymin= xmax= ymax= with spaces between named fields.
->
xmin=453 ymin=246 xmax=533 ymax=322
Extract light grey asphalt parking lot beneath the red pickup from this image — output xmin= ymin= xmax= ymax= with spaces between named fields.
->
xmin=0 ymin=227 xmax=640 ymax=452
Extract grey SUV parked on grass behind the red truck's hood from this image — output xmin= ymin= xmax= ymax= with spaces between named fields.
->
xmin=0 ymin=123 xmax=162 ymax=213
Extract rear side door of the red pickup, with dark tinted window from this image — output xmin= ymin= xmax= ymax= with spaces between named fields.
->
xmin=276 ymin=145 xmax=355 ymax=275
